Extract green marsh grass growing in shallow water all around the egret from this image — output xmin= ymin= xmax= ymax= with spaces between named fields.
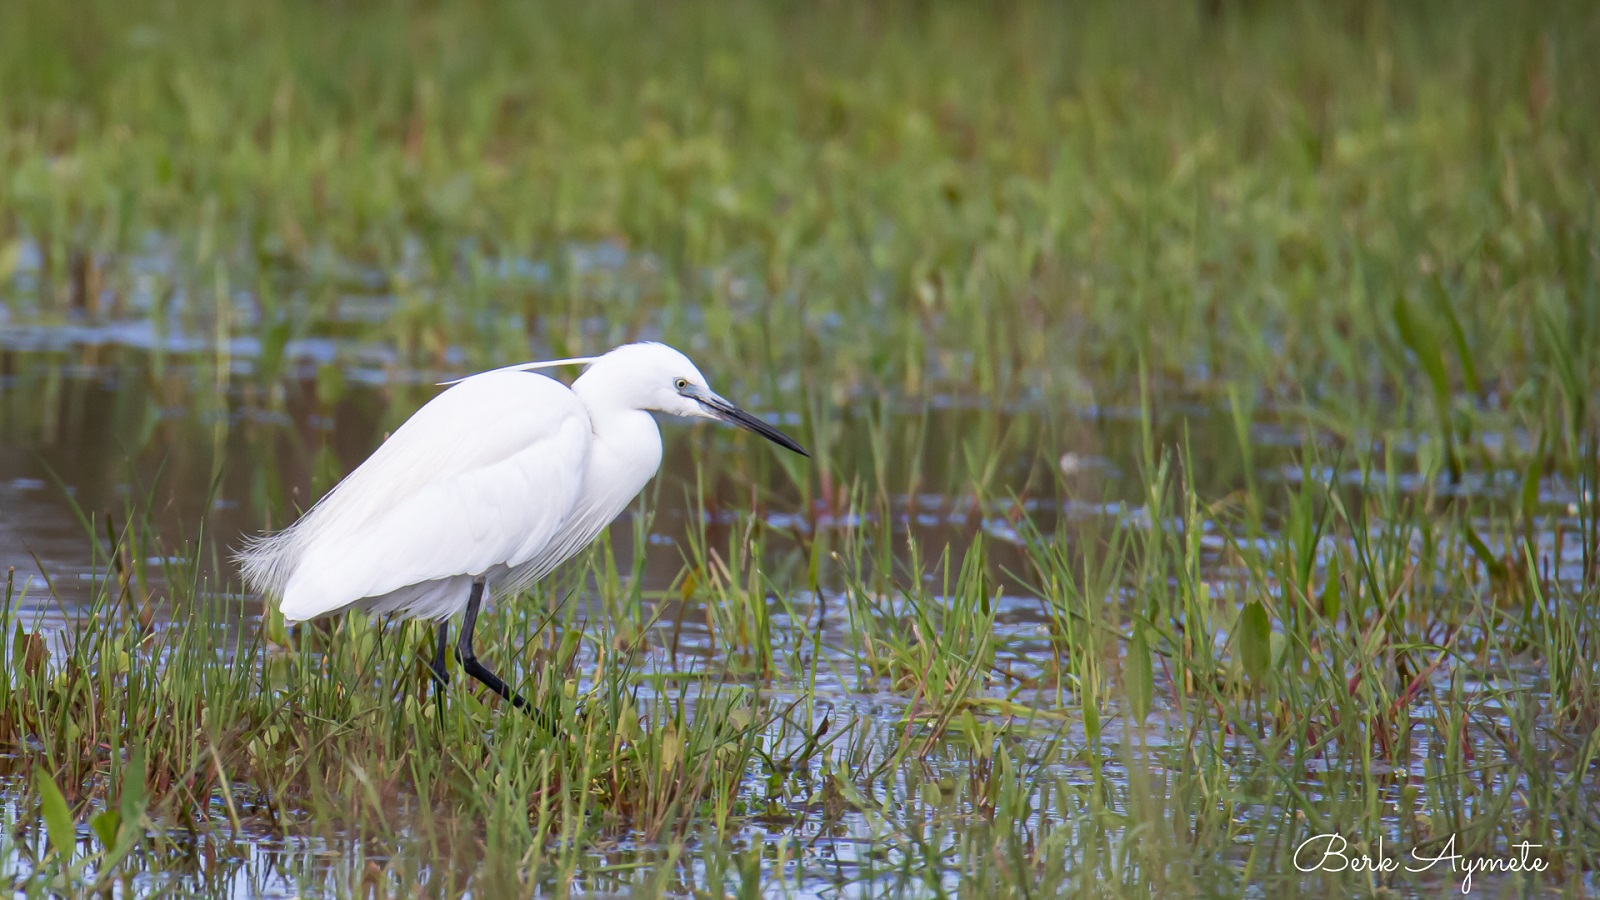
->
xmin=0 ymin=0 xmax=1600 ymax=897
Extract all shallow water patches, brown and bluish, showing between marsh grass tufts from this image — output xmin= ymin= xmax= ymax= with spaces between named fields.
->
xmin=0 ymin=235 xmax=1584 ymax=897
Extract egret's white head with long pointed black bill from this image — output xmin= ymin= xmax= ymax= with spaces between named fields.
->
xmin=573 ymin=343 xmax=810 ymax=456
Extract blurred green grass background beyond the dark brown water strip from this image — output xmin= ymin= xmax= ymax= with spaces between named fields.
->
xmin=0 ymin=2 xmax=1600 ymax=424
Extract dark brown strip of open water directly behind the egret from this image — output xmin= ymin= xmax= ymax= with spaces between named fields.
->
xmin=0 ymin=331 xmax=1286 ymax=604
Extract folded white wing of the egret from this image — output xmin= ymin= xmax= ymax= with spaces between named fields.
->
xmin=262 ymin=373 xmax=592 ymax=620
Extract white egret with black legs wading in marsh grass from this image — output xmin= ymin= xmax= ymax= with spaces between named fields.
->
xmin=238 ymin=343 xmax=808 ymax=711
